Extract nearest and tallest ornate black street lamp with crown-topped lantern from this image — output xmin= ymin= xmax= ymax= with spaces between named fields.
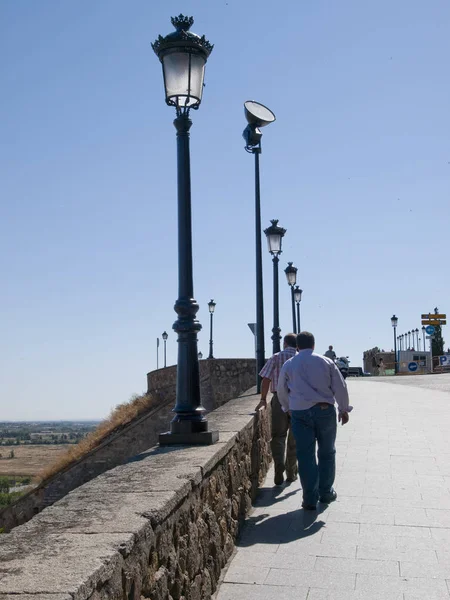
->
xmin=152 ymin=15 xmax=219 ymax=444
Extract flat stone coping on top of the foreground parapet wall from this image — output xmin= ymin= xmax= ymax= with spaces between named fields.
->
xmin=0 ymin=388 xmax=258 ymax=600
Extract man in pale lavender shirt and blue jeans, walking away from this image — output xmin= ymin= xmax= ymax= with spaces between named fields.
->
xmin=277 ymin=331 xmax=352 ymax=510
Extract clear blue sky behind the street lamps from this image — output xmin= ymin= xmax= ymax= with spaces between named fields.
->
xmin=0 ymin=0 xmax=450 ymax=420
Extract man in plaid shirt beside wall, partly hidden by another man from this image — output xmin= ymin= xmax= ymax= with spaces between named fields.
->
xmin=255 ymin=333 xmax=298 ymax=485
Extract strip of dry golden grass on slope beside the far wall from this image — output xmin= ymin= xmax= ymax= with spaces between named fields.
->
xmin=39 ymin=395 xmax=153 ymax=481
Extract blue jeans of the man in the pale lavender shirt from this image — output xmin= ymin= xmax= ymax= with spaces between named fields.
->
xmin=291 ymin=404 xmax=337 ymax=505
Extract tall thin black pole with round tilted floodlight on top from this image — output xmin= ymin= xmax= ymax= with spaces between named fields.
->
xmin=242 ymin=100 xmax=275 ymax=394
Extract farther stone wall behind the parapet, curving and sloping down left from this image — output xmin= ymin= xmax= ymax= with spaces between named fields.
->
xmin=0 ymin=359 xmax=256 ymax=531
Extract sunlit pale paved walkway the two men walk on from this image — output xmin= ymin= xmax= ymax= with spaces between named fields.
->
xmin=217 ymin=375 xmax=450 ymax=600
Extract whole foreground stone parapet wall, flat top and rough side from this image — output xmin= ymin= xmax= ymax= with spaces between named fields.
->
xmin=0 ymin=394 xmax=270 ymax=600
